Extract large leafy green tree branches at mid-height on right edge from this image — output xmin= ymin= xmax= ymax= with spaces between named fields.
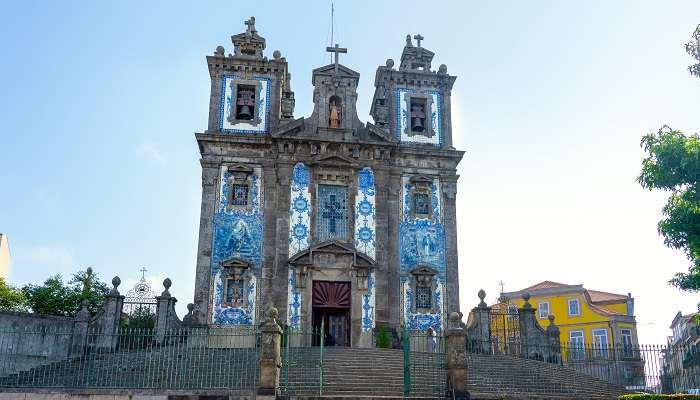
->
xmin=637 ymin=125 xmax=700 ymax=291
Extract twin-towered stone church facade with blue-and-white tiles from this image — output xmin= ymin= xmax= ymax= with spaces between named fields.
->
xmin=194 ymin=17 xmax=464 ymax=347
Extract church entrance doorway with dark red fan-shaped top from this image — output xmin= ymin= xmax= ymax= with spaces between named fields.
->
xmin=313 ymin=281 xmax=351 ymax=346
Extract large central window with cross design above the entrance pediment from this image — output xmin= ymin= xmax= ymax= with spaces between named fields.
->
xmin=316 ymin=185 xmax=348 ymax=241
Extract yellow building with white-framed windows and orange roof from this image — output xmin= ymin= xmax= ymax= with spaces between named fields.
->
xmin=497 ymin=281 xmax=639 ymax=349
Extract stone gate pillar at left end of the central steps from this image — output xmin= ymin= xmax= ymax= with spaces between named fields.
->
xmin=258 ymin=307 xmax=282 ymax=399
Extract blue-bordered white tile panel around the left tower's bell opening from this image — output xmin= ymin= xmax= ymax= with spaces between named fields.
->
xmin=219 ymin=75 xmax=270 ymax=134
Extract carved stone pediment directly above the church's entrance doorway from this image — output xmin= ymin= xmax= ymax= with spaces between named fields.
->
xmin=288 ymin=240 xmax=376 ymax=269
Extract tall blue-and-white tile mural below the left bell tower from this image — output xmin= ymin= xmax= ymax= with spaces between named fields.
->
xmin=211 ymin=166 xmax=263 ymax=325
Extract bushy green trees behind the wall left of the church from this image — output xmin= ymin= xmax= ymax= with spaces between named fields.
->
xmin=22 ymin=268 xmax=108 ymax=317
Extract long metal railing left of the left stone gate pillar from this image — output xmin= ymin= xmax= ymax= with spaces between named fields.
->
xmin=0 ymin=328 xmax=260 ymax=394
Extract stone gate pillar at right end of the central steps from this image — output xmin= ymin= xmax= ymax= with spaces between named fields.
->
xmin=447 ymin=312 xmax=469 ymax=400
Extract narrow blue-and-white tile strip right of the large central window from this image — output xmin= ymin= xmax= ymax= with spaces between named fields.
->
xmin=355 ymin=168 xmax=376 ymax=259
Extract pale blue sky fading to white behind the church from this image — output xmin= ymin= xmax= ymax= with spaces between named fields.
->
xmin=0 ymin=1 xmax=700 ymax=343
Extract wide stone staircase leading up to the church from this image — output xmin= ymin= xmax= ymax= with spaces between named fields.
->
xmin=0 ymin=347 xmax=624 ymax=400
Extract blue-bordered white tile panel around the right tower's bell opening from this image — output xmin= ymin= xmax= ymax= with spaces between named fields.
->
xmin=396 ymin=88 xmax=443 ymax=146
